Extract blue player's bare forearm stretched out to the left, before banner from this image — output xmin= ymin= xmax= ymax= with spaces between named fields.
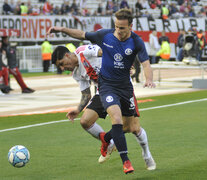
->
xmin=47 ymin=26 xmax=85 ymax=40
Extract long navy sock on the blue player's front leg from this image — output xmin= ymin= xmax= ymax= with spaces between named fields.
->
xmin=111 ymin=124 xmax=129 ymax=163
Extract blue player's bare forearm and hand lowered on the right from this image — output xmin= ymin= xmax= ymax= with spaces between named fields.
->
xmin=142 ymin=60 xmax=156 ymax=88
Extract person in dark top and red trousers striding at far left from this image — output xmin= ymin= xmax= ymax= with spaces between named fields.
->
xmin=2 ymin=36 xmax=35 ymax=93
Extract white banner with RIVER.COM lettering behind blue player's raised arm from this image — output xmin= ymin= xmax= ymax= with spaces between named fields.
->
xmin=0 ymin=16 xmax=111 ymax=42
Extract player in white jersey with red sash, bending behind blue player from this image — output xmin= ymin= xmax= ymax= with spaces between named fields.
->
xmin=52 ymin=45 xmax=156 ymax=170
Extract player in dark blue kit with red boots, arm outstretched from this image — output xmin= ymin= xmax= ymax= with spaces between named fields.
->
xmin=48 ymin=9 xmax=155 ymax=174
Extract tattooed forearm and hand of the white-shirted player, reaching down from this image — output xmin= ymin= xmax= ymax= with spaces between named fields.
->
xmin=66 ymin=87 xmax=91 ymax=122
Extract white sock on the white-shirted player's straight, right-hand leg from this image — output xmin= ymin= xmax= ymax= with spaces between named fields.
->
xmin=135 ymin=128 xmax=151 ymax=159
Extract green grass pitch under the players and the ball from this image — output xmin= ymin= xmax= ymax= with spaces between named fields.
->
xmin=0 ymin=90 xmax=207 ymax=180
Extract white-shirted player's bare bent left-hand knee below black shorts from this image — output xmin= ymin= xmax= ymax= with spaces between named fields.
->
xmin=80 ymin=109 xmax=99 ymax=128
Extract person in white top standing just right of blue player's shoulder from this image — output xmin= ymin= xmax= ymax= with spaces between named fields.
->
xmin=149 ymin=31 xmax=160 ymax=64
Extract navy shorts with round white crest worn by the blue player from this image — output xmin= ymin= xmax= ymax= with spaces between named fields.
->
xmin=98 ymin=75 xmax=135 ymax=116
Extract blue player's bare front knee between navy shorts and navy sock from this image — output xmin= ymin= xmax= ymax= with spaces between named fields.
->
xmin=106 ymin=105 xmax=123 ymax=125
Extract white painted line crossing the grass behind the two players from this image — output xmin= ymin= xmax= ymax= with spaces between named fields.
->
xmin=0 ymin=98 xmax=207 ymax=133
